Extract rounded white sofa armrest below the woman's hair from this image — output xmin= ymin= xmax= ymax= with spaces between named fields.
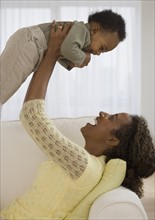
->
xmin=89 ymin=187 xmax=148 ymax=220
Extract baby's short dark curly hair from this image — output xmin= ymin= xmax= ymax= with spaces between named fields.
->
xmin=88 ymin=10 xmax=126 ymax=41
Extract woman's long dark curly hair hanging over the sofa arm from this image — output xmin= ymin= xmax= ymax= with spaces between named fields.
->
xmin=105 ymin=115 xmax=155 ymax=198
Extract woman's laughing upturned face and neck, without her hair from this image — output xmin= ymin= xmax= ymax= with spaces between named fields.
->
xmin=81 ymin=112 xmax=132 ymax=156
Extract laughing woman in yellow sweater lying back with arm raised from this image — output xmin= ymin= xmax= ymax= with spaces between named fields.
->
xmin=1 ymin=21 xmax=155 ymax=220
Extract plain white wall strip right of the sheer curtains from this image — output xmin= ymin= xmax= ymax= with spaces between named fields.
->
xmin=141 ymin=0 xmax=155 ymax=137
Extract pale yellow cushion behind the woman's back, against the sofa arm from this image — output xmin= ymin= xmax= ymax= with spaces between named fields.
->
xmin=65 ymin=159 xmax=126 ymax=220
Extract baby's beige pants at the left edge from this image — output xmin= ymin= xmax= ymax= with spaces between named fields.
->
xmin=0 ymin=28 xmax=45 ymax=104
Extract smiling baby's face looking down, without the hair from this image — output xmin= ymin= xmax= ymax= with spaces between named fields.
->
xmin=86 ymin=29 xmax=119 ymax=55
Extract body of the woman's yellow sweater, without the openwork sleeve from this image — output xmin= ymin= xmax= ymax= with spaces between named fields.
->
xmin=1 ymin=158 xmax=104 ymax=220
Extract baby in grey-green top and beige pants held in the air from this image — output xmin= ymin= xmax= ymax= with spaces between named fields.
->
xmin=0 ymin=10 xmax=126 ymax=104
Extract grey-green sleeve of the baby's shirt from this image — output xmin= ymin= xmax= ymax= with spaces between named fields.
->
xmin=60 ymin=21 xmax=90 ymax=66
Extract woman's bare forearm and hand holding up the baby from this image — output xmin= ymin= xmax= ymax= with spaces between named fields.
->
xmin=25 ymin=22 xmax=71 ymax=102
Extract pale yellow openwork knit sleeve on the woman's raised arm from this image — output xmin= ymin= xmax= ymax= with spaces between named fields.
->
xmin=20 ymin=99 xmax=88 ymax=179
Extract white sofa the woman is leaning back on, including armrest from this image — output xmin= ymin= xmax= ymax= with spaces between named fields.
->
xmin=1 ymin=117 xmax=148 ymax=220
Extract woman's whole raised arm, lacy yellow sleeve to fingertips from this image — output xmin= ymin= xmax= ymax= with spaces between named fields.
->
xmin=20 ymin=21 xmax=88 ymax=179
